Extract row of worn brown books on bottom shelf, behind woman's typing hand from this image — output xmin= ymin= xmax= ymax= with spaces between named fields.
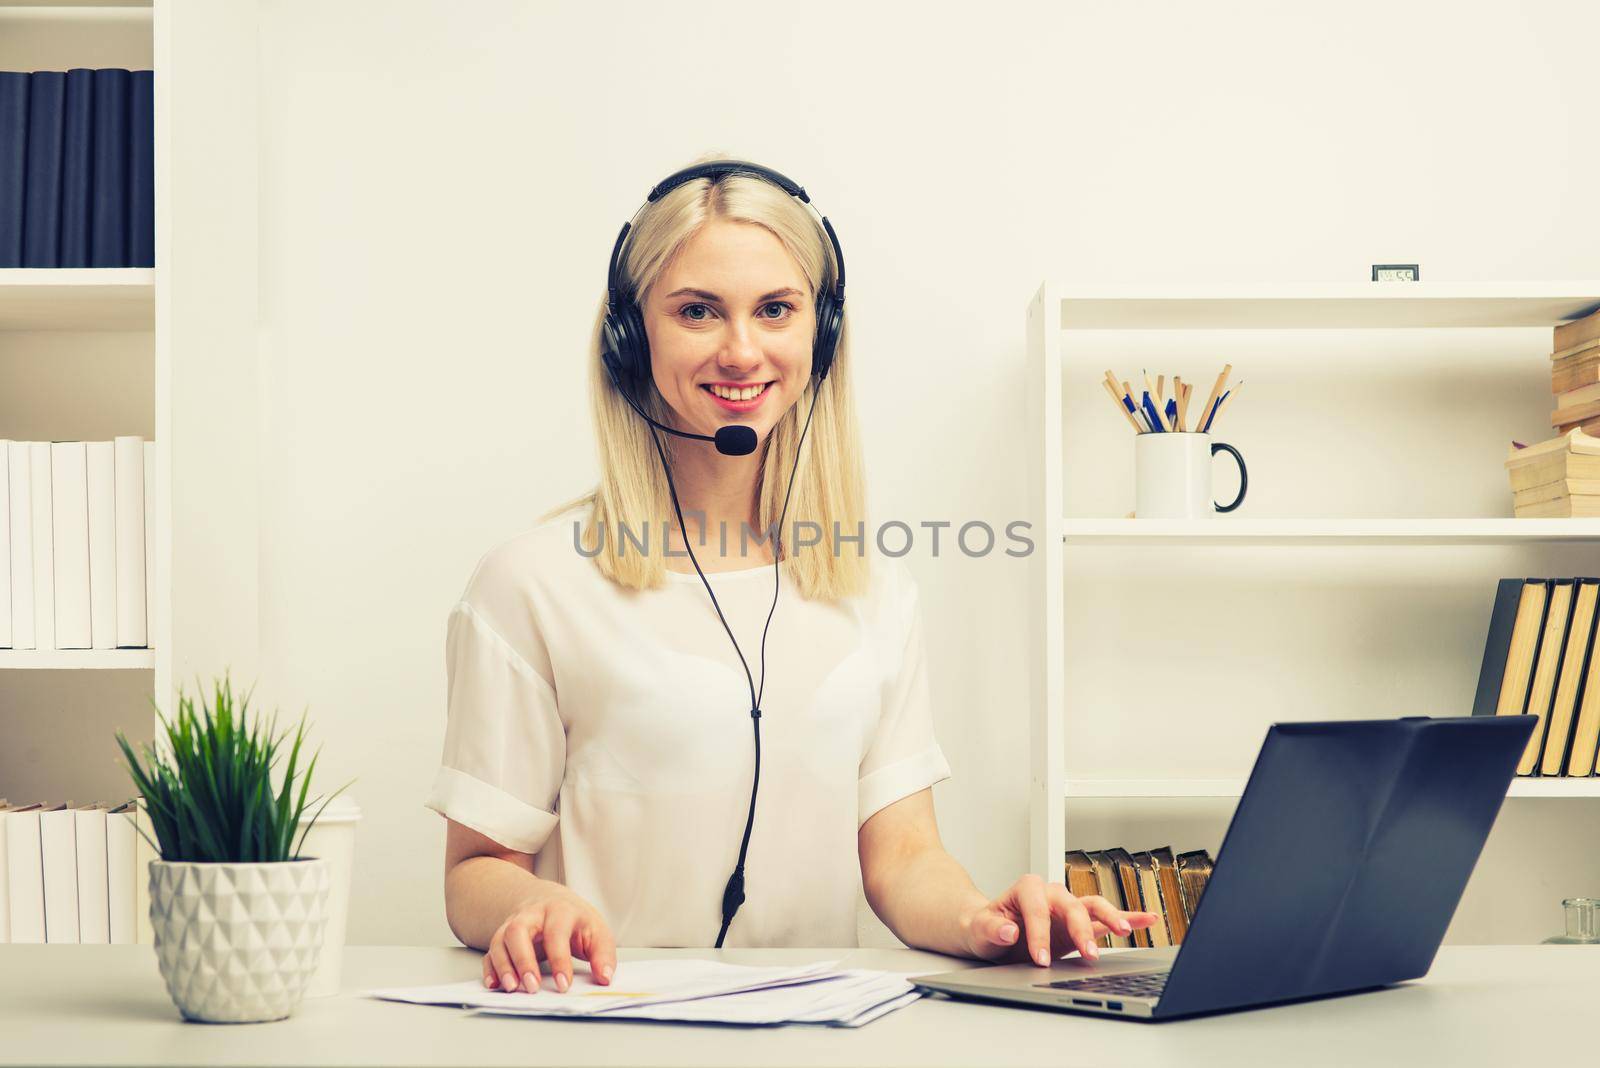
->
xmin=1066 ymin=847 xmax=1211 ymax=948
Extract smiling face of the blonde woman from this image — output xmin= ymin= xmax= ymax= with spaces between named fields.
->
xmin=645 ymin=219 xmax=816 ymax=438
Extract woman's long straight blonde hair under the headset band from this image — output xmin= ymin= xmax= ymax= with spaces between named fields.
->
xmin=544 ymin=153 xmax=870 ymax=601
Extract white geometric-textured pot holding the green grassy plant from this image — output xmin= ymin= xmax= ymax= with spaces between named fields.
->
xmin=150 ymin=857 xmax=330 ymax=1023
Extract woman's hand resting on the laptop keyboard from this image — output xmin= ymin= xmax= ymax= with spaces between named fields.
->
xmin=962 ymin=875 xmax=1160 ymax=967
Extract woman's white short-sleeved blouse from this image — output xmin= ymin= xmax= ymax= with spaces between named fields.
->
xmin=426 ymin=507 xmax=950 ymax=946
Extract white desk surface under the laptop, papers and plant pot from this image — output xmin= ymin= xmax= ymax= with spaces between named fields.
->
xmin=0 ymin=945 xmax=1600 ymax=1068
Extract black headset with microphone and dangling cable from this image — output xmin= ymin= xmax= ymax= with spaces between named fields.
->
xmin=600 ymin=160 xmax=845 ymax=950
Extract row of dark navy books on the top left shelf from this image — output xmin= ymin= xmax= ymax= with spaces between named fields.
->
xmin=0 ymin=67 xmax=155 ymax=267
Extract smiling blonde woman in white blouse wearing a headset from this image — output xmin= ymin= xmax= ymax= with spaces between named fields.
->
xmin=427 ymin=160 xmax=1155 ymax=991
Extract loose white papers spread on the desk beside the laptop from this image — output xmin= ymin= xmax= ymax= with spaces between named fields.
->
xmin=366 ymin=959 xmax=920 ymax=1026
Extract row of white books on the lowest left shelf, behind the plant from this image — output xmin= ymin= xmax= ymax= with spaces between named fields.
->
xmin=0 ymin=798 xmax=155 ymax=945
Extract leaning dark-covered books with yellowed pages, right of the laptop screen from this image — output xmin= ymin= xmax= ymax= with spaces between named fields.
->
xmin=1472 ymin=577 xmax=1600 ymax=775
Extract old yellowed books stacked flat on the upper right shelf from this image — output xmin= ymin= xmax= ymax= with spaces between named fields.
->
xmin=1506 ymin=303 xmax=1600 ymax=518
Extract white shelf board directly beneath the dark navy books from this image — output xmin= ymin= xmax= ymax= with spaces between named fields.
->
xmin=0 ymin=267 xmax=155 ymax=331
